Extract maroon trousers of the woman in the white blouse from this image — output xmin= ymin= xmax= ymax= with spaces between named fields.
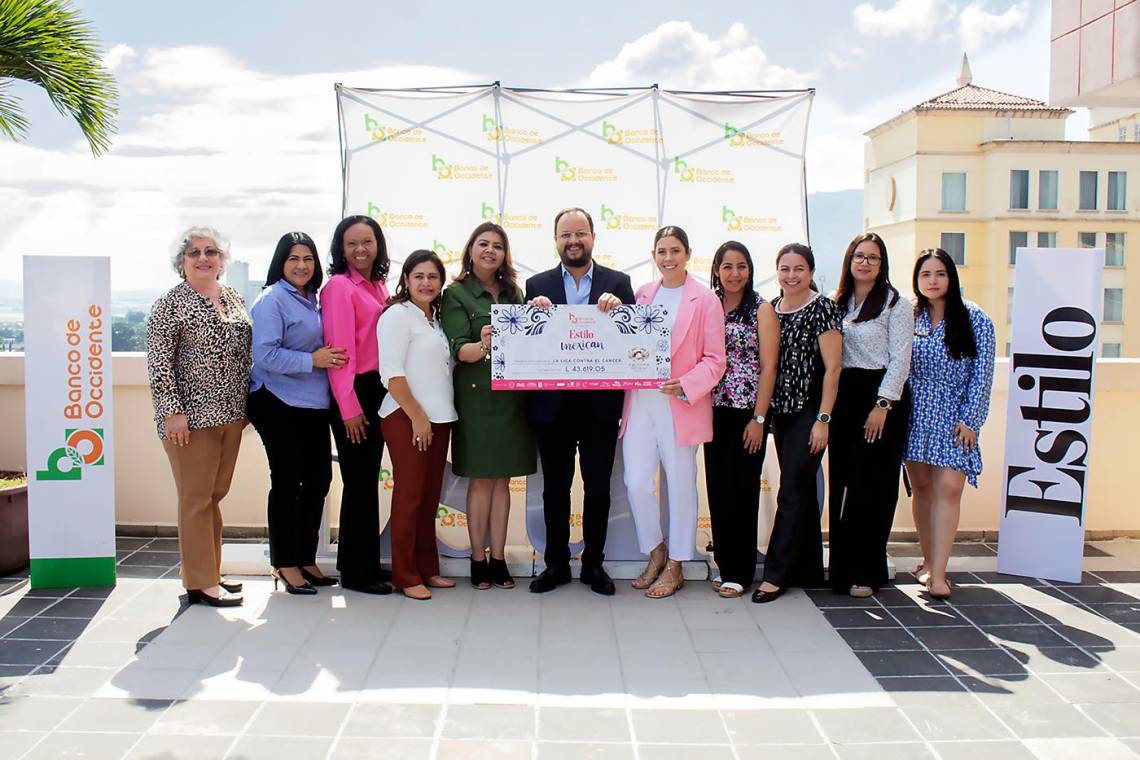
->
xmin=380 ymin=409 xmax=451 ymax=588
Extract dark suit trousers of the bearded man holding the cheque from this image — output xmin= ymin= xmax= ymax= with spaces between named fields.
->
xmin=535 ymin=391 xmax=618 ymax=567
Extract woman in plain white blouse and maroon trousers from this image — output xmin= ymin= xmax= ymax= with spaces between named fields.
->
xmin=376 ymin=251 xmax=457 ymax=599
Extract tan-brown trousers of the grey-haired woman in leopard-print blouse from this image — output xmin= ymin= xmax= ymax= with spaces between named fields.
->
xmin=162 ymin=420 xmax=245 ymax=589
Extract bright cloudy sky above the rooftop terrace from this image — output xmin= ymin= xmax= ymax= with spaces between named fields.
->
xmin=0 ymin=0 xmax=1071 ymax=289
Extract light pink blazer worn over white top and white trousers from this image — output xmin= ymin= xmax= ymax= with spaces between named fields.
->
xmin=619 ymin=275 xmax=725 ymax=446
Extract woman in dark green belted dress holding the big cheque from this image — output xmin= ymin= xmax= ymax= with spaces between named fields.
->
xmin=440 ymin=222 xmax=537 ymax=589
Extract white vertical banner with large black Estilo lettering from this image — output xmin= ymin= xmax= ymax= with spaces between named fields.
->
xmin=998 ymin=248 xmax=1105 ymax=582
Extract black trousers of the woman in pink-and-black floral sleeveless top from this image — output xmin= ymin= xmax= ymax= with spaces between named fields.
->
xmin=705 ymin=407 xmax=768 ymax=589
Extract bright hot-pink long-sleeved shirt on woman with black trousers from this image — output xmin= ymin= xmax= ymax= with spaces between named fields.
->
xmin=320 ymin=267 xmax=388 ymax=419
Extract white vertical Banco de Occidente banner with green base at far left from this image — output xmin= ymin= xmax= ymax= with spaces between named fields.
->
xmin=24 ymin=256 xmax=115 ymax=588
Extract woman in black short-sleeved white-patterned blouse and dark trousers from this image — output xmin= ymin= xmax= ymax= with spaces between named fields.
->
xmin=752 ymin=243 xmax=842 ymax=604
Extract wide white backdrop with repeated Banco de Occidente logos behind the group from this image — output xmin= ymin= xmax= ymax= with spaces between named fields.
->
xmin=336 ymin=84 xmax=814 ymax=559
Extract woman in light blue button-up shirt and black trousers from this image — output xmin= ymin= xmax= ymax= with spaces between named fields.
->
xmin=246 ymin=232 xmax=345 ymax=594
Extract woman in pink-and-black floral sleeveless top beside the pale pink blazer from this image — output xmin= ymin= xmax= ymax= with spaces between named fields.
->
xmin=705 ymin=240 xmax=780 ymax=598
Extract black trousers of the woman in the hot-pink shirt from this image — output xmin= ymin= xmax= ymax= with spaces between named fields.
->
xmin=332 ymin=371 xmax=388 ymax=585
